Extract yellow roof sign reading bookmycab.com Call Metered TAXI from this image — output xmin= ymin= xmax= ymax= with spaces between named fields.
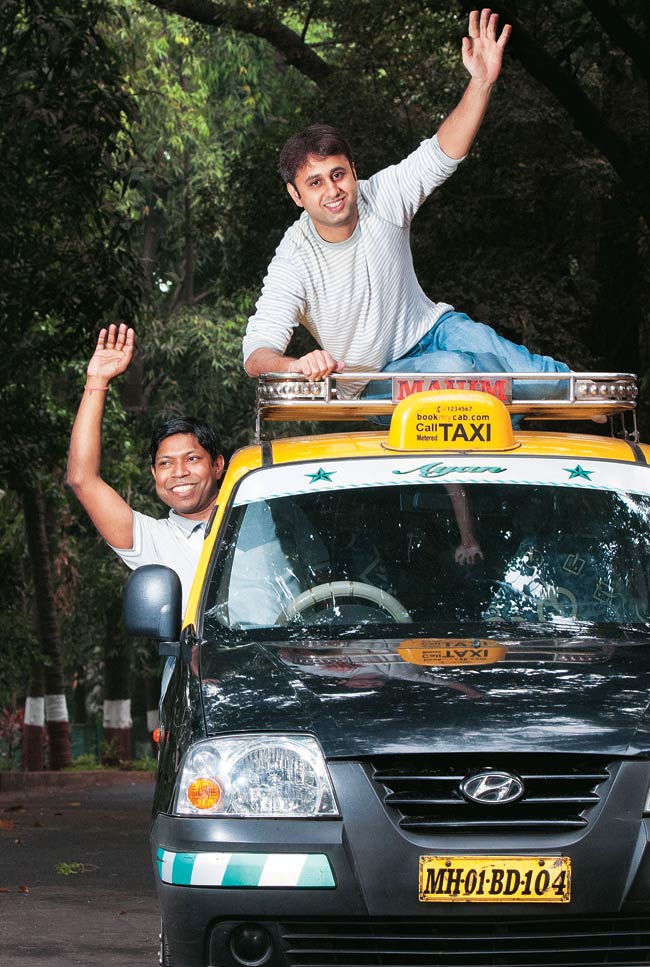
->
xmin=386 ymin=390 xmax=519 ymax=451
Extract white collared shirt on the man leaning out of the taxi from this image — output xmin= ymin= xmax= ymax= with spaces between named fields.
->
xmin=111 ymin=510 xmax=207 ymax=611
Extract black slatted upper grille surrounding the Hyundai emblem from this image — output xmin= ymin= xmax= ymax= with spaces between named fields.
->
xmin=371 ymin=756 xmax=610 ymax=833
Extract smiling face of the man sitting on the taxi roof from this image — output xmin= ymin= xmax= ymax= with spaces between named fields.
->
xmin=287 ymin=154 xmax=359 ymax=242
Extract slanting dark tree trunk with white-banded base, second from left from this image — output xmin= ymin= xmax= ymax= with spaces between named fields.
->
xmin=22 ymin=485 xmax=72 ymax=769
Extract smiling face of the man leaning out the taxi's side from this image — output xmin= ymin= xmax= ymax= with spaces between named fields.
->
xmin=151 ymin=433 xmax=224 ymax=520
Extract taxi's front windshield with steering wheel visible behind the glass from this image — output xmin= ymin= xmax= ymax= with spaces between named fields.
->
xmin=203 ymin=482 xmax=650 ymax=641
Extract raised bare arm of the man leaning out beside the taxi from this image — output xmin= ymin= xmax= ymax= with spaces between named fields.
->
xmin=66 ymin=325 xmax=135 ymax=548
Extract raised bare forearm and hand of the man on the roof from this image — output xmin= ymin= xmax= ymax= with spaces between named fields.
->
xmin=438 ymin=8 xmax=512 ymax=159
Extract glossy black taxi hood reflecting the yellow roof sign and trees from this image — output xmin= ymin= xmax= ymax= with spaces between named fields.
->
xmin=196 ymin=638 xmax=650 ymax=758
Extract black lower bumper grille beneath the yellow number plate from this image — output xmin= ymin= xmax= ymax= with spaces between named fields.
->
xmin=279 ymin=916 xmax=650 ymax=967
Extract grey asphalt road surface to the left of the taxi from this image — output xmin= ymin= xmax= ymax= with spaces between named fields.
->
xmin=0 ymin=773 xmax=159 ymax=967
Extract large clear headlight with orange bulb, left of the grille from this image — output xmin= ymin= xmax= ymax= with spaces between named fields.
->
xmin=174 ymin=734 xmax=339 ymax=819
